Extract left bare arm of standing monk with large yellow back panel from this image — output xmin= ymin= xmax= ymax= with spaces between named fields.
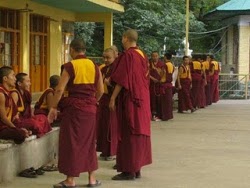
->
xmin=51 ymin=69 xmax=70 ymax=108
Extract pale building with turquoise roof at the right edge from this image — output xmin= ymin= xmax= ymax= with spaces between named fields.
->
xmin=205 ymin=0 xmax=250 ymax=74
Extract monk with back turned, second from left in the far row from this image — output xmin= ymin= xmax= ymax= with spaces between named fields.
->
xmin=160 ymin=53 xmax=175 ymax=121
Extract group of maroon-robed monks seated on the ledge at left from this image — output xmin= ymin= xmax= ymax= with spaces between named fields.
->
xmin=0 ymin=66 xmax=59 ymax=144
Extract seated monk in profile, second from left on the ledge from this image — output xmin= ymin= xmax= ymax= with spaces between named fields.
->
xmin=11 ymin=73 xmax=51 ymax=137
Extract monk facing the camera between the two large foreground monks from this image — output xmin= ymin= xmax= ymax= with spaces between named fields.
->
xmin=96 ymin=48 xmax=117 ymax=161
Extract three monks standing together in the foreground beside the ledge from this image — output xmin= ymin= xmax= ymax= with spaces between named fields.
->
xmin=44 ymin=29 xmax=152 ymax=187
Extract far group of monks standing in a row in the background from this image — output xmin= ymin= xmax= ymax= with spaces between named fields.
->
xmin=149 ymin=51 xmax=220 ymax=121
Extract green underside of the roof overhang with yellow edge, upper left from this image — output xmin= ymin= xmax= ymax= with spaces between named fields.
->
xmin=32 ymin=0 xmax=124 ymax=13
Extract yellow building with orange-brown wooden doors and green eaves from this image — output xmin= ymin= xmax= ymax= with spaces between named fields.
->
xmin=0 ymin=0 xmax=124 ymax=92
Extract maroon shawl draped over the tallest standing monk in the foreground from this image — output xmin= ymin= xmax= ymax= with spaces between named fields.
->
xmin=111 ymin=48 xmax=151 ymax=136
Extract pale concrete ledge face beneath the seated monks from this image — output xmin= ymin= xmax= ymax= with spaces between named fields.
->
xmin=0 ymin=127 xmax=59 ymax=183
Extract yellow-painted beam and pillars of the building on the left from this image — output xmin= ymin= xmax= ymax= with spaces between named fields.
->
xmin=0 ymin=0 xmax=117 ymax=81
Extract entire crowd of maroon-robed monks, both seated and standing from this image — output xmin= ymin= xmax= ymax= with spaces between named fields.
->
xmin=0 ymin=26 xmax=219 ymax=188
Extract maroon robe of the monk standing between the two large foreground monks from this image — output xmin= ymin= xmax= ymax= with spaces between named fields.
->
xmin=96 ymin=64 xmax=118 ymax=157
